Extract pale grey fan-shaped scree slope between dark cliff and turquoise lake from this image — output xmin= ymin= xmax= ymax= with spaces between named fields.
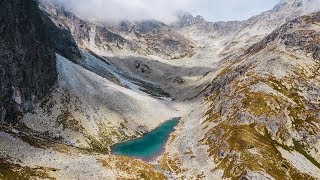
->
xmin=22 ymin=52 xmax=179 ymax=149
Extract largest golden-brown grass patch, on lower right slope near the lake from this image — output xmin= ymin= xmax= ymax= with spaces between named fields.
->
xmin=203 ymin=124 xmax=312 ymax=179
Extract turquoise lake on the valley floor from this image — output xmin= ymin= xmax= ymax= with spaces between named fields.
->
xmin=111 ymin=118 xmax=180 ymax=160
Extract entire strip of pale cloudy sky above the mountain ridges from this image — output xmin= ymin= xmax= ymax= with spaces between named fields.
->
xmin=54 ymin=0 xmax=279 ymax=22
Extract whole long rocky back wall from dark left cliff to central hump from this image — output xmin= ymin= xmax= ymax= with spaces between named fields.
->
xmin=40 ymin=0 xmax=194 ymax=59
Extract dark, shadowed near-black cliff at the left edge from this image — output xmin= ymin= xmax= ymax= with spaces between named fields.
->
xmin=0 ymin=0 xmax=80 ymax=121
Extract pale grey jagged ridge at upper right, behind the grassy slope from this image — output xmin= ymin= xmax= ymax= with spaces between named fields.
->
xmin=171 ymin=0 xmax=318 ymax=58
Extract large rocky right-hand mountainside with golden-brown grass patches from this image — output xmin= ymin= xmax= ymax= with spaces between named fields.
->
xmin=162 ymin=10 xmax=320 ymax=179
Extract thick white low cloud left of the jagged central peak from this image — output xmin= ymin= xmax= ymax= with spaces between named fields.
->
xmin=54 ymin=0 xmax=193 ymax=22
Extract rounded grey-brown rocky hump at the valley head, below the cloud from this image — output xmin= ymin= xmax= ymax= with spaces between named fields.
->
xmin=108 ymin=20 xmax=195 ymax=59
